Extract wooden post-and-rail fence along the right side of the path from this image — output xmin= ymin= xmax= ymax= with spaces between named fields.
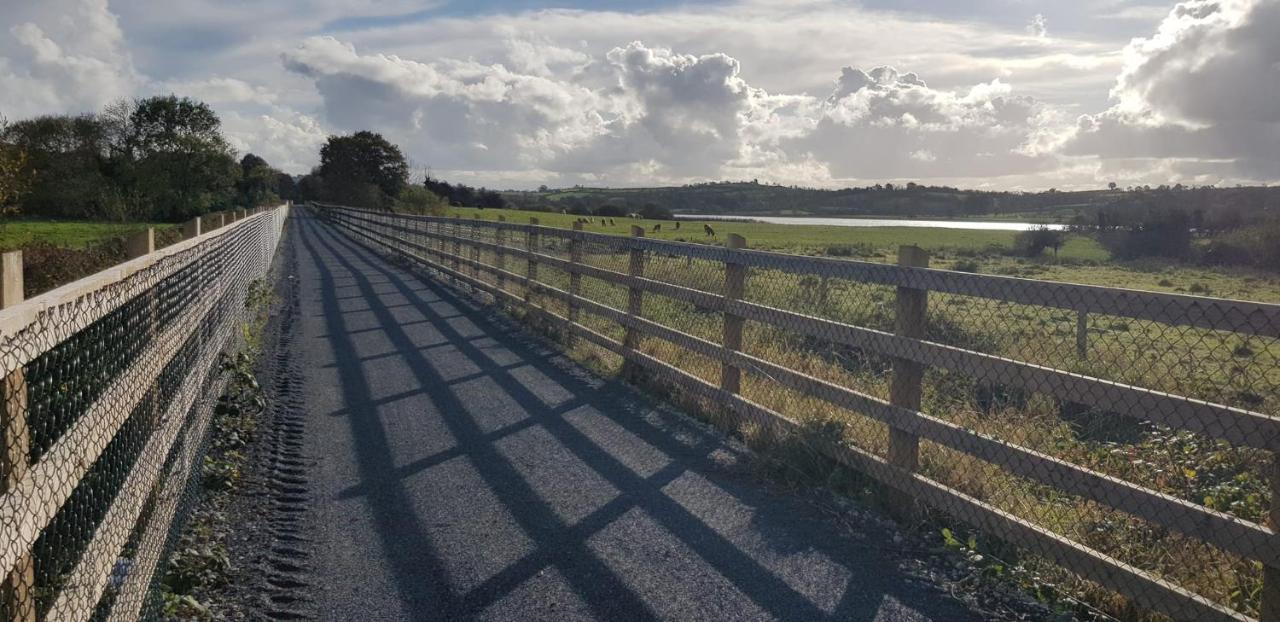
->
xmin=321 ymin=207 xmax=1280 ymax=621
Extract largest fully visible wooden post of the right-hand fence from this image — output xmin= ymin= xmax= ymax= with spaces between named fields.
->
xmin=888 ymin=246 xmax=929 ymax=520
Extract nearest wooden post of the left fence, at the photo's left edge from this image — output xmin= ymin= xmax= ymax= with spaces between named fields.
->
xmin=0 ymin=251 xmax=36 ymax=622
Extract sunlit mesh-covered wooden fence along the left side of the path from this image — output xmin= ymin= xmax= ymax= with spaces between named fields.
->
xmin=0 ymin=206 xmax=288 ymax=622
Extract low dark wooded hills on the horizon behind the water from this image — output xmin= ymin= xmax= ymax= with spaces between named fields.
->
xmin=503 ymin=182 xmax=1280 ymax=223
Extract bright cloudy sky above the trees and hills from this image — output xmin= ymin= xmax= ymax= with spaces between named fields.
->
xmin=0 ymin=0 xmax=1280 ymax=191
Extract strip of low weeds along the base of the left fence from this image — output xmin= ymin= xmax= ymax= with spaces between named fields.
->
xmin=160 ymin=280 xmax=271 ymax=621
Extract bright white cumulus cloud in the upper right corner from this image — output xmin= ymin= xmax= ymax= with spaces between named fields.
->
xmin=1065 ymin=0 xmax=1280 ymax=180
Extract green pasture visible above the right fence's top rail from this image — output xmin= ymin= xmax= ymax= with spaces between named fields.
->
xmin=447 ymin=207 xmax=1280 ymax=302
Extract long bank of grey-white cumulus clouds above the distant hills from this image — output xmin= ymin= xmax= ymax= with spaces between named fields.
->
xmin=284 ymin=37 xmax=1070 ymax=183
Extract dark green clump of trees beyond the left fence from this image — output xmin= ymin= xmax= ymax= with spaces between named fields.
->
xmin=0 ymin=95 xmax=296 ymax=221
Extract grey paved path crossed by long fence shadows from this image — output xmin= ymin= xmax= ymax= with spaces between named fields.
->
xmin=282 ymin=210 xmax=979 ymax=621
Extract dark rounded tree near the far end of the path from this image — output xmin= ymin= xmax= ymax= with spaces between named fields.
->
xmin=320 ymin=132 xmax=408 ymax=207
